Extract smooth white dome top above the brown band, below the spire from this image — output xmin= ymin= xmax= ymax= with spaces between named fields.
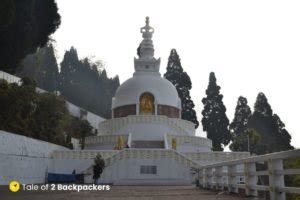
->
xmin=112 ymin=72 xmax=181 ymax=110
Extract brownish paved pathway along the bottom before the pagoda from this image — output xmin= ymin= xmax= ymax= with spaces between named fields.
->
xmin=0 ymin=186 xmax=251 ymax=200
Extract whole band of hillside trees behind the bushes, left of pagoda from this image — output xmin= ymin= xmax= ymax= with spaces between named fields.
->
xmin=16 ymin=43 xmax=120 ymax=118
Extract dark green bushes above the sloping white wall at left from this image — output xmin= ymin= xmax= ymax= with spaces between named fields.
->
xmin=0 ymin=78 xmax=92 ymax=146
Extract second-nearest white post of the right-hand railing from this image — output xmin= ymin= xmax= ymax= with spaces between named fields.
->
xmin=244 ymin=163 xmax=257 ymax=196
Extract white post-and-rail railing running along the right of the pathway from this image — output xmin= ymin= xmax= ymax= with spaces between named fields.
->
xmin=198 ymin=149 xmax=300 ymax=200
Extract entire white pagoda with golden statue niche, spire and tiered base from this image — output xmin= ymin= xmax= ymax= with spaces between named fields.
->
xmin=49 ymin=17 xmax=249 ymax=185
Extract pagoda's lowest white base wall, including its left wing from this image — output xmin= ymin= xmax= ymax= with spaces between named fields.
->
xmin=51 ymin=150 xmax=195 ymax=185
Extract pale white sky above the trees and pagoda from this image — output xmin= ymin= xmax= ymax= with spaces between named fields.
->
xmin=53 ymin=0 xmax=300 ymax=147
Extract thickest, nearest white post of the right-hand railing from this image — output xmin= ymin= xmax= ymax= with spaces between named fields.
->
xmin=268 ymin=159 xmax=286 ymax=200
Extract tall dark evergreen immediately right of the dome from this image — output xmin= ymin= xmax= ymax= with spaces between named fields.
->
xmin=164 ymin=49 xmax=199 ymax=128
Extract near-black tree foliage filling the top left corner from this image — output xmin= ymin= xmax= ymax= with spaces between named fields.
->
xmin=0 ymin=0 xmax=60 ymax=73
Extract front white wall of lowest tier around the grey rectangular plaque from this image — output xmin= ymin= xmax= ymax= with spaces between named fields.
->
xmin=95 ymin=158 xmax=193 ymax=185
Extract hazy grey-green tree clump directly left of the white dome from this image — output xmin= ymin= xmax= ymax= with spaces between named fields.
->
xmin=60 ymin=47 xmax=120 ymax=118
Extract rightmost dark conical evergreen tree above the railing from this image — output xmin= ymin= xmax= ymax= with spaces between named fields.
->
xmin=248 ymin=93 xmax=293 ymax=155
